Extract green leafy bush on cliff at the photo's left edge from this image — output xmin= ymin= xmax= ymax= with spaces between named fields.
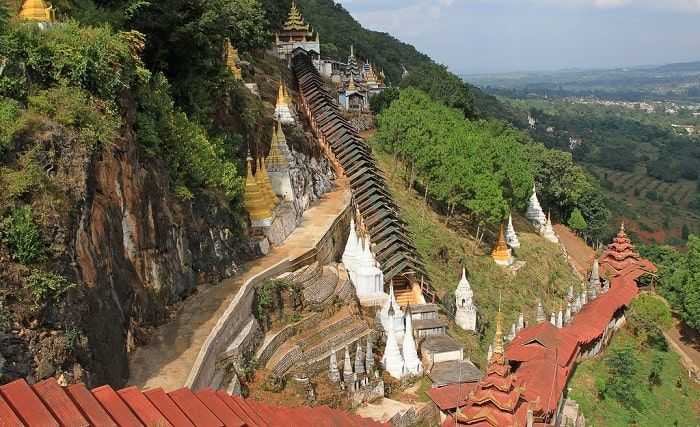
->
xmin=0 ymin=206 xmax=46 ymax=264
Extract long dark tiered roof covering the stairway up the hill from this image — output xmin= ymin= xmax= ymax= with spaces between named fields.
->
xmin=292 ymin=49 xmax=438 ymax=300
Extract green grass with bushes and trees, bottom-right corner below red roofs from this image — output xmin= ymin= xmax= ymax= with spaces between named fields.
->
xmin=569 ymin=293 xmax=700 ymax=426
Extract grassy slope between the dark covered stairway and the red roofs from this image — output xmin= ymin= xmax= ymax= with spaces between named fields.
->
xmin=373 ymin=139 xmax=580 ymax=364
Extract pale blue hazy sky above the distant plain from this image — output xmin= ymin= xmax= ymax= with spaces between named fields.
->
xmin=336 ymin=0 xmax=700 ymax=73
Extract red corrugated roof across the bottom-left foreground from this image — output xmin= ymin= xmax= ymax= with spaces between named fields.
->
xmin=0 ymin=379 xmax=387 ymax=427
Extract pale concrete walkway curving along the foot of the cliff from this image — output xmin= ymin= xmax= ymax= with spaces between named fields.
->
xmin=128 ymin=187 xmax=350 ymax=392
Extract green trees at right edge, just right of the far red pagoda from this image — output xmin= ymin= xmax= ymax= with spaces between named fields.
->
xmin=639 ymin=239 xmax=700 ymax=331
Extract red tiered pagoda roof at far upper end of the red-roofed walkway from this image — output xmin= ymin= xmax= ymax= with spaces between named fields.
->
xmin=599 ymin=223 xmax=657 ymax=280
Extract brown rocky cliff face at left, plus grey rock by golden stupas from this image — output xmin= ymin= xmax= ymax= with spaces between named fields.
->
xmin=0 ymin=94 xmax=334 ymax=392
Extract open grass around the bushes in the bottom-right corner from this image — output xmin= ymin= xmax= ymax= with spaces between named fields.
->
xmin=569 ymin=329 xmax=700 ymax=427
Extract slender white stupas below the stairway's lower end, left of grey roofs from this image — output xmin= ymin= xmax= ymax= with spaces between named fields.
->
xmin=381 ymin=296 xmax=423 ymax=379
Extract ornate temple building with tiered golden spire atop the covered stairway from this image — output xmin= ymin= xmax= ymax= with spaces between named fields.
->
xmin=275 ymin=1 xmax=321 ymax=68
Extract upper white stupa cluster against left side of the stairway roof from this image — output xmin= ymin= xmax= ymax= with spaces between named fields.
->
xmin=342 ymin=212 xmax=386 ymax=305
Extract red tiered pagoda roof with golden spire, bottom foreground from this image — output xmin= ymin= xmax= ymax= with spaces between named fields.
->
xmin=443 ymin=310 xmax=529 ymax=426
